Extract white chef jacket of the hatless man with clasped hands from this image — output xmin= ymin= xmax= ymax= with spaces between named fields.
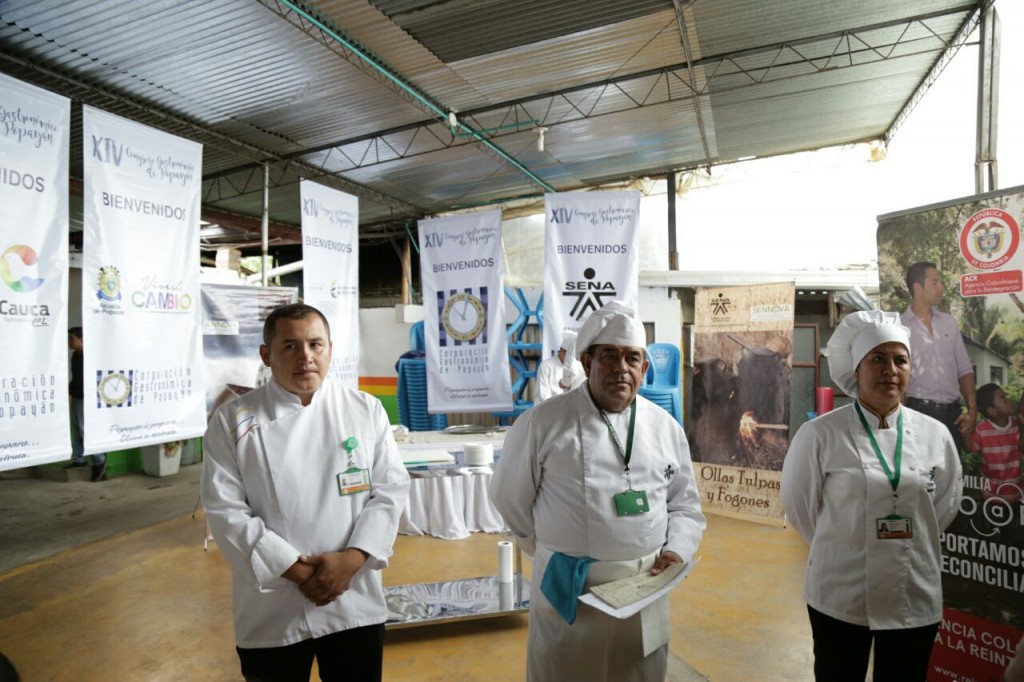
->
xmin=202 ymin=380 xmax=409 ymax=648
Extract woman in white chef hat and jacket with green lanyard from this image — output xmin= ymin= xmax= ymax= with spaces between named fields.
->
xmin=781 ymin=310 xmax=964 ymax=682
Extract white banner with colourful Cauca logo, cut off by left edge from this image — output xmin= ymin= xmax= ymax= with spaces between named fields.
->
xmin=0 ymin=74 xmax=71 ymax=471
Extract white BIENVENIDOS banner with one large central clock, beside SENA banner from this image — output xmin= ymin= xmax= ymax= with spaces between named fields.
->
xmin=419 ymin=211 xmax=512 ymax=414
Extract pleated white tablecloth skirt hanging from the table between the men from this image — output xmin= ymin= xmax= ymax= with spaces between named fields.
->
xmin=398 ymin=468 xmax=506 ymax=540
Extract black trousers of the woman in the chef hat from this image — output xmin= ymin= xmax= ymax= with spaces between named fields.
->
xmin=807 ymin=606 xmax=939 ymax=682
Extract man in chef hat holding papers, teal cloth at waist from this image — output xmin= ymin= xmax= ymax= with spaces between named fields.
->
xmin=489 ymin=301 xmax=706 ymax=682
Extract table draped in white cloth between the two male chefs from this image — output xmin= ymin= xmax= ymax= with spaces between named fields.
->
xmin=398 ymin=430 xmax=507 ymax=540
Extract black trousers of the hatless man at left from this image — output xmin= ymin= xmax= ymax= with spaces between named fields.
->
xmin=234 ymin=623 xmax=384 ymax=682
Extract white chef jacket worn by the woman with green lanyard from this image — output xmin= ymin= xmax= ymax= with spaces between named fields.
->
xmin=781 ymin=403 xmax=964 ymax=630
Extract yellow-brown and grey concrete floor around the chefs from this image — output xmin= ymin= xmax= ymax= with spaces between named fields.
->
xmin=0 ymin=466 xmax=813 ymax=682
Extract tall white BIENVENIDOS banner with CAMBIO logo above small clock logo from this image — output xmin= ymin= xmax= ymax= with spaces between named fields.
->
xmin=82 ymin=106 xmax=206 ymax=453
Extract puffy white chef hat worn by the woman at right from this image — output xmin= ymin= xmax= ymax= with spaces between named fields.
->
xmin=828 ymin=310 xmax=910 ymax=396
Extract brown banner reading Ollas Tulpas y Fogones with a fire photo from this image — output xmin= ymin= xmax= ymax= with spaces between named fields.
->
xmin=687 ymin=283 xmax=796 ymax=520
